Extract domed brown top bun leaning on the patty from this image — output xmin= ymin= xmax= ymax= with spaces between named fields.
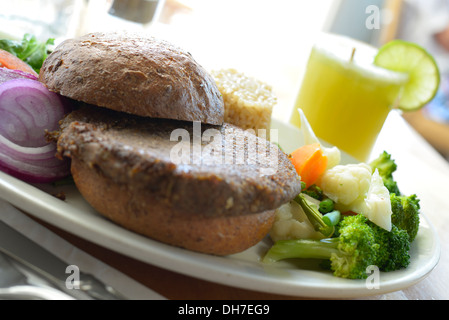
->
xmin=39 ymin=32 xmax=224 ymax=125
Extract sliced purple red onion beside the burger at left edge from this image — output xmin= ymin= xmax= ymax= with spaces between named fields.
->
xmin=0 ymin=79 xmax=71 ymax=183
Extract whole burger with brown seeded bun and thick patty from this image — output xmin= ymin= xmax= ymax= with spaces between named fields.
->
xmin=39 ymin=32 xmax=301 ymax=256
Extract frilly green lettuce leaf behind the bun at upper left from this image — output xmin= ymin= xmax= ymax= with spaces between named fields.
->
xmin=0 ymin=33 xmax=55 ymax=73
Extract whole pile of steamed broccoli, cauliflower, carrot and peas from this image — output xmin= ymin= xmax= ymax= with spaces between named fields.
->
xmin=263 ymin=112 xmax=420 ymax=279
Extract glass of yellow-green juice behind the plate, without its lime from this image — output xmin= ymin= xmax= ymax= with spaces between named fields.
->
xmin=291 ymin=35 xmax=408 ymax=161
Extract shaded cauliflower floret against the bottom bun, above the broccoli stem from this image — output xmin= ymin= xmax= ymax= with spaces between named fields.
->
xmin=270 ymin=201 xmax=324 ymax=242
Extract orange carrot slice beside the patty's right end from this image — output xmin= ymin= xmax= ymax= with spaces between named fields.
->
xmin=290 ymin=143 xmax=327 ymax=187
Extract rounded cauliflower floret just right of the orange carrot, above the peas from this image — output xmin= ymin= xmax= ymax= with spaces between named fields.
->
xmin=318 ymin=163 xmax=372 ymax=211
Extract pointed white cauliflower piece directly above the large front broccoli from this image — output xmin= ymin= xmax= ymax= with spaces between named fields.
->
xmin=351 ymin=169 xmax=393 ymax=231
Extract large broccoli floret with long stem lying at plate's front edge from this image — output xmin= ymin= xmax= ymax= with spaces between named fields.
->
xmin=263 ymin=215 xmax=410 ymax=279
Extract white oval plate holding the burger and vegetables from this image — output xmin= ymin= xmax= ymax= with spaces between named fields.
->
xmin=0 ymin=120 xmax=440 ymax=298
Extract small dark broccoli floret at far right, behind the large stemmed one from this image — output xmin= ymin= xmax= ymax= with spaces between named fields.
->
xmin=390 ymin=193 xmax=421 ymax=242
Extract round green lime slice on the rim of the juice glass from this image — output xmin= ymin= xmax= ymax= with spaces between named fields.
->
xmin=374 ymin=40 xmax=440 ymax=111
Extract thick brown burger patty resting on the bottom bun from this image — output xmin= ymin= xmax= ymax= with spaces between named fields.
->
xmin=58 ymin=106 xmax=301 ymax=216
